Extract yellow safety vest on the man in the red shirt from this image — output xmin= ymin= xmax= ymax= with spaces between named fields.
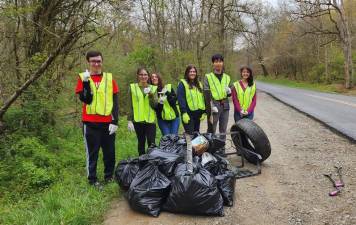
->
xmin=79 ymin=73 xmax=113 ymax=116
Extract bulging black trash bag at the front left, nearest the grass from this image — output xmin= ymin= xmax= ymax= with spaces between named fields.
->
xmin=128 ymin=162 xmax=171 ymax=217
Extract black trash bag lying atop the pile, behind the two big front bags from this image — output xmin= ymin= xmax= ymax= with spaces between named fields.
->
xmin=139 ymin=148 xmax=184 ymax=177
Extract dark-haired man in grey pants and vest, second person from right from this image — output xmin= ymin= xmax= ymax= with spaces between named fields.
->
xmin=204 ymin=54 xmax=231 ymax=140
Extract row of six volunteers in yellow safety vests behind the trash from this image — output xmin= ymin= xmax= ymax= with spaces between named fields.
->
xmin=76 ymin=51 xmax=256 ymax=185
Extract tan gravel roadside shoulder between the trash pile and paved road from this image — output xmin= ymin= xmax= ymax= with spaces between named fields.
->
xmin=104 ymin=93 xmax=356 ymax=225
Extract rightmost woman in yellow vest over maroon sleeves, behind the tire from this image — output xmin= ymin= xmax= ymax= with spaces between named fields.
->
xmin=231 ymin=66 xmax=256 ymax=122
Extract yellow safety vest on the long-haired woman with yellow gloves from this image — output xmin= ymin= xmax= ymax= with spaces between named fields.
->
xmin=181 ymin=79 xmax=205 ymax=111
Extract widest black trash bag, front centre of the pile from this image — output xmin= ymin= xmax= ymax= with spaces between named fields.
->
xmin=163 ymin=163 xmax=224 ymax=216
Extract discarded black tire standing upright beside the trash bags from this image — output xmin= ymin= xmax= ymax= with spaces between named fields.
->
xmin=230 ymin=119 xmax=271 ymax=164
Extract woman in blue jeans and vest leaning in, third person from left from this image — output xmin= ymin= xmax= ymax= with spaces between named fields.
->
xmin=151 ymin=73 xmax=179 ymax=136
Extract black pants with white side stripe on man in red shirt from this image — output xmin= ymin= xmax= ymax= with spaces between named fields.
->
xmin=83 ymin=124 xmax=115 ymax=182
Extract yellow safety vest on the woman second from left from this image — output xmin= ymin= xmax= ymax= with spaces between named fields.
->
xmin=130 ymin=83 xmax=157 ymax=123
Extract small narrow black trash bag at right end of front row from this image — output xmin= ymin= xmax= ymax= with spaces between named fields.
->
xmin=215 ymin=170 xmax=236 ymax=206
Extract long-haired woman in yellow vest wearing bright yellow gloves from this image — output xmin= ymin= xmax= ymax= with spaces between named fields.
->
xmin=177 ymin=65 xmax=206 ymax=134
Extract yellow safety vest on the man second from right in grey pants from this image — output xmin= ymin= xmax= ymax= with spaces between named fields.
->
xmin=205 ymin=73 xmax=230 ymax=101
